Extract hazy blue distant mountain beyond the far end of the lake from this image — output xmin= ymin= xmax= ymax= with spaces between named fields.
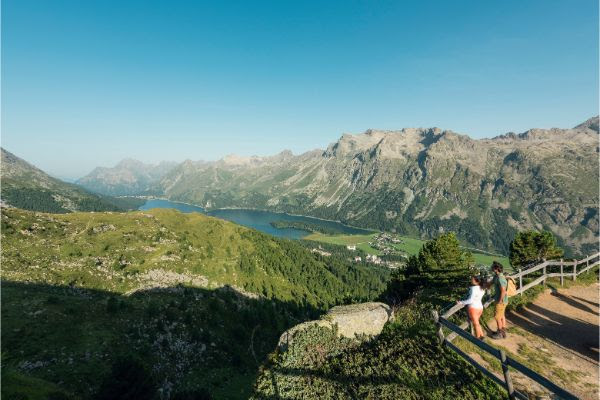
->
xmin=77 ymin=159 xmax=177 ymax=196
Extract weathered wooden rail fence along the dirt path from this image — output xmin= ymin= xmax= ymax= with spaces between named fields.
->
xmin=433 ymin=253 xmax=600 ymax=400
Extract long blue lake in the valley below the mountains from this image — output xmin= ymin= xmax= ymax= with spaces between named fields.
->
xmin=139 ymin=199 xmax=369 ymax=239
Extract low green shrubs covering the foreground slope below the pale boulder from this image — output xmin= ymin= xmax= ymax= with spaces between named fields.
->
xmin=252 ymin=306 xmax=505 ymax=400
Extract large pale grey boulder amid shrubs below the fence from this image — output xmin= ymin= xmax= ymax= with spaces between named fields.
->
xmin=279 ymin=302 xmax=393 ymax=350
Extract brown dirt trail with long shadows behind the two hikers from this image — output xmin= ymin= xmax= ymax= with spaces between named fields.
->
xmin=474 ymin=283 xmax=600 ymax=400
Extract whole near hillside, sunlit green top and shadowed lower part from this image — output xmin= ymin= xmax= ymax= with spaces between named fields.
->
xmin=2 ymin=209 xmax=387 ymax=398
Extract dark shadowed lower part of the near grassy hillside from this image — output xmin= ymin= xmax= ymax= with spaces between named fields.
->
xmin=1 ymin=281 xmax=321 ymax=399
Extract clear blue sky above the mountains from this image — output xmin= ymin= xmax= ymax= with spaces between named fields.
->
xmin=2 ymin=0 xmax=599 ymax=178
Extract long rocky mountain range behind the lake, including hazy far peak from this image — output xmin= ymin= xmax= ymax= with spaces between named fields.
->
xmin=78 ymin=117 xmax=599 ymax=253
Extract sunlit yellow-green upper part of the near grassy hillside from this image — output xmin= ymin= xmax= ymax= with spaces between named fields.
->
xmin=3 ymin=209 xmax=386 ymax=304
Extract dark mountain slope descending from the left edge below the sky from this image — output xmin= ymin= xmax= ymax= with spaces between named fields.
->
xmin=1 ymin=149 xmax=135 ymax=213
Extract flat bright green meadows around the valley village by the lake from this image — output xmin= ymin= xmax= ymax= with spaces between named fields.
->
xmin=304 ymin=232 xmax=510 ymax=266
